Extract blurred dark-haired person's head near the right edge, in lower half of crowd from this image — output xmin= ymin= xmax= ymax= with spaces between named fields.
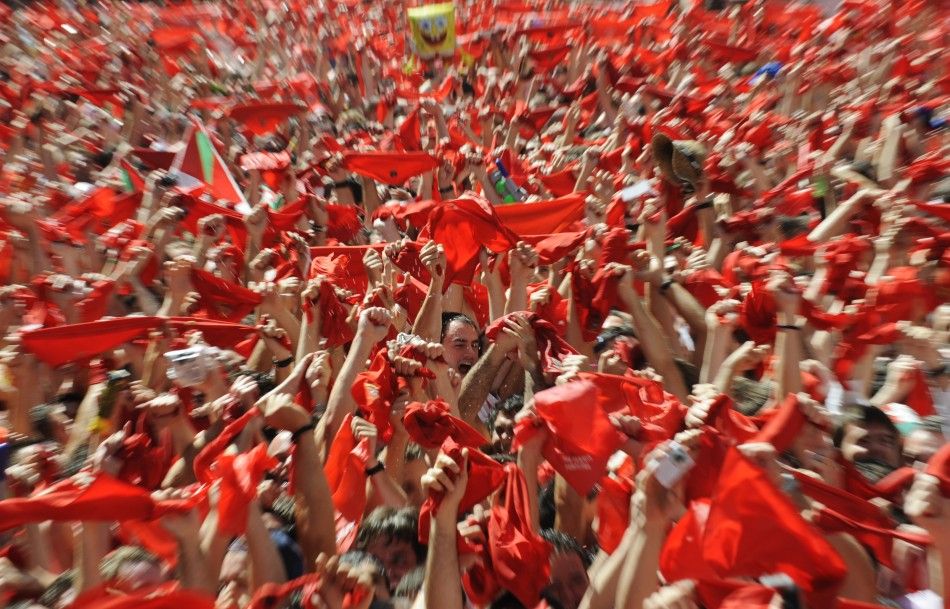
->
xmin=834 ymin=406 xmax=902 ymax=478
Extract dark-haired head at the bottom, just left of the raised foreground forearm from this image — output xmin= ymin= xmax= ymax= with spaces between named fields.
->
xmin=354 ymin=507 xmax=426 ymax=591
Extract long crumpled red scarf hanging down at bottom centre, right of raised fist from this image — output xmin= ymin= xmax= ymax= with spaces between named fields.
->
xmin=488 ymin=463 xmax=551 ymax=607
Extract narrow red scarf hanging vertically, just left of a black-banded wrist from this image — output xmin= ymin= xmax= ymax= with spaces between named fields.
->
xmin=323 ymin=415 xmax=370 ymax=552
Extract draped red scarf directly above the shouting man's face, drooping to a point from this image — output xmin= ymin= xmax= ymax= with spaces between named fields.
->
xmin=427 ymin=199 xmax=518 ymax=285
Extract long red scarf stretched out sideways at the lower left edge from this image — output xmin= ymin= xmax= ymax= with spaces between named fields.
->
xmin=0 ymin=472 xmax=198 ymax=530
